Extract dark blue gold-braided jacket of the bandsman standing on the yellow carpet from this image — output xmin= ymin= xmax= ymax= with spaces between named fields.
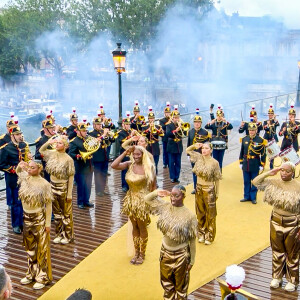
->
xmin=240 ymin=135 xmax=267 ymax=172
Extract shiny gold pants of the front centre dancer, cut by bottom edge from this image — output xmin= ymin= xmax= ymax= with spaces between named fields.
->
xmin=160 ymin=246 xmax=191 ymax=300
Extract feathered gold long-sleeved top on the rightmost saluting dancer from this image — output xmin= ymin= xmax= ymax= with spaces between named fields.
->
xmin=253 ymin=173 xmax=300 ymax=214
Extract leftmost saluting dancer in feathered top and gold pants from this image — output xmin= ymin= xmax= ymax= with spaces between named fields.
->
xmin=16 ymin=161 xmax=53 ymax=290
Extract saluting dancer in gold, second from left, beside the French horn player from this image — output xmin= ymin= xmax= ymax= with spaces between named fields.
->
xmin=40 ymin=135 xmax=75 ymax=244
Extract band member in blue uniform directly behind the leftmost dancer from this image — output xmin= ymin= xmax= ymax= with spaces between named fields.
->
xmin=0 ymin=126 xmax=31 ymax=234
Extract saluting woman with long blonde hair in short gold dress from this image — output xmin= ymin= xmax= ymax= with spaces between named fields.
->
xmin=111 ymin=146 xmax=156 ymax=265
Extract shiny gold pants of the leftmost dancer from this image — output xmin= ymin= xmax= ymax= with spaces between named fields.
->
xmin=23 ymin=211 xmax=52 ymax=284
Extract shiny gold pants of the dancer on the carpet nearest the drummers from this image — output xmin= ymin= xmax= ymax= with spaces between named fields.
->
xmin=195 ymin=183 xmax=217 ymax=242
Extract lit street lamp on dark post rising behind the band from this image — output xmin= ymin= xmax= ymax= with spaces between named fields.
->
xmin=112 ymin=43 xmax=126 ymax=129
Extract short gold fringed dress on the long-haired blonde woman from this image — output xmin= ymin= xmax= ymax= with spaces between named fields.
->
xmin=122 ymin=164 xmax=150 ymax=221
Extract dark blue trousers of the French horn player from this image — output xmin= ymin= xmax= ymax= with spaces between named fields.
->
xmin=75 ymin=172 xmax=93 ymax=205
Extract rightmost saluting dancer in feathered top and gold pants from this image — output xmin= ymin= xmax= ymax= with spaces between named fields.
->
xmin=253 ymin=162 xmax=300 ymax=292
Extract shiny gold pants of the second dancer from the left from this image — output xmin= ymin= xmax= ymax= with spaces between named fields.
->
xmin=51 ymin=182 xmax=74 ymax=242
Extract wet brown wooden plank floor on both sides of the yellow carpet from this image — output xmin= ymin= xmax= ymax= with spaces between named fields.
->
xmin=0 ymin=135 xmax=300 ymax=300
